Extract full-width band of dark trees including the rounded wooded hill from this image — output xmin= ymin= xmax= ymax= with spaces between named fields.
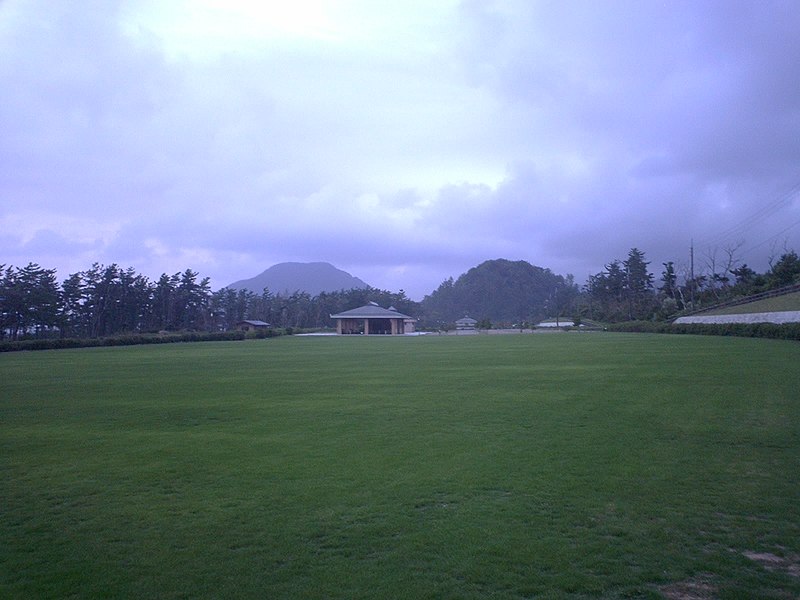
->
xmin=0 ymin=248 xmax=800 ymax=340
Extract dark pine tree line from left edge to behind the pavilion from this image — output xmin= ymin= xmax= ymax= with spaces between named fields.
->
xmin=0 ymin=263 xmax=417 ymax=340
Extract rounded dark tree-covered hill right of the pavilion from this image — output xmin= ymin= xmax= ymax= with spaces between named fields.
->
xmin=422 ymin=259 xmax=578 ymax=324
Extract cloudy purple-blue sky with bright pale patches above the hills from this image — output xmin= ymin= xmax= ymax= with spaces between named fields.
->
xmin=0 ymin=0 xmax=800 ymax=299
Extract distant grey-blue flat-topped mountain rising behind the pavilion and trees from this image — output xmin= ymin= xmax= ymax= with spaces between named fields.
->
xmin=228 ymin=262 xmax=370 ymax=296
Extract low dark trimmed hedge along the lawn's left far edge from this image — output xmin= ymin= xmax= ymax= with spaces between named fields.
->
xmin=0 ymin=329 xmax=283 ymax=352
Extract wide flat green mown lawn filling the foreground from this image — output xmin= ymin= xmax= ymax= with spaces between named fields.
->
xmin=0 ymin=333 xmax=800 ymax=598
